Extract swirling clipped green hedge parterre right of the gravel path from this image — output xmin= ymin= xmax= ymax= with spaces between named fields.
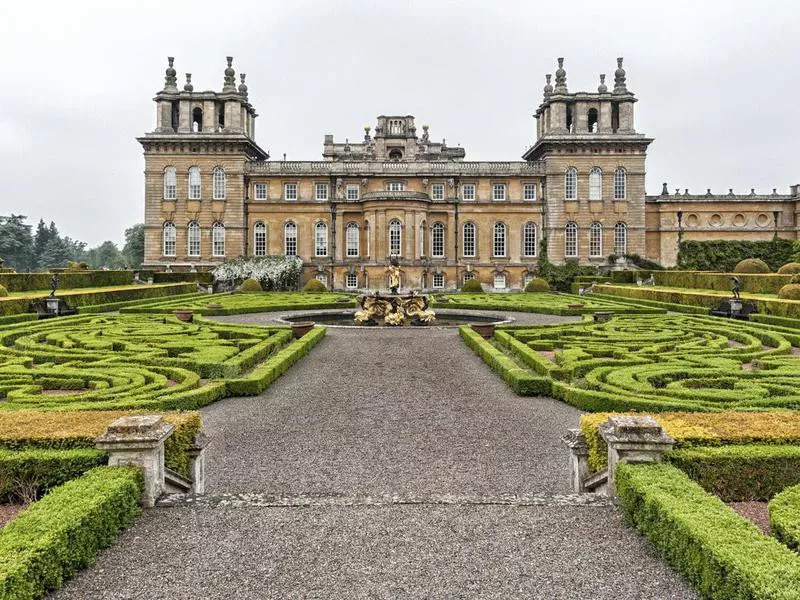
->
xmin=462 ymin=314 xmax=800 ymax=412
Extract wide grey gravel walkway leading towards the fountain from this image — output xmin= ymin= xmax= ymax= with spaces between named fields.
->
xmin=53 ymin=322 xmax=695 ymax=600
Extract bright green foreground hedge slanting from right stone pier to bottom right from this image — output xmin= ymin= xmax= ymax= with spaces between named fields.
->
xmin=616 ymin=464 xmax=800 ymax=600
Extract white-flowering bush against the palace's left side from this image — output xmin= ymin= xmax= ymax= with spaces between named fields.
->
xmin=213 ymin=256 xmax=303 ymax=292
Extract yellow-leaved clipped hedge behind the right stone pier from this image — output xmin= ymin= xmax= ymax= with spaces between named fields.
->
xmin=581 ymin=411 xmax=800 ymax=472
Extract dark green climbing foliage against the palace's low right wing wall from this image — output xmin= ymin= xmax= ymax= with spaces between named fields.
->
xmin=678 ymin=239 xmax=793 ymax=272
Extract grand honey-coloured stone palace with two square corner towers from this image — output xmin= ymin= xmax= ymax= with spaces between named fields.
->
xmin=138 ymin=57 xmax=800 ymax=290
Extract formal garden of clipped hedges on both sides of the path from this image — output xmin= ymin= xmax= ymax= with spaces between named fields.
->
xmin=0 ymin=243 xmax=800 ymax=599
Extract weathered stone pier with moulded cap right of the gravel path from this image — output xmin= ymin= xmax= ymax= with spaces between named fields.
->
xmin=600 ymin=415 xmax=675 ymax=496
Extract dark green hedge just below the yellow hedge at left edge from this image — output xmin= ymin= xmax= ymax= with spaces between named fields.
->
xmin=0 ymin=448 xmax=106 ymax=502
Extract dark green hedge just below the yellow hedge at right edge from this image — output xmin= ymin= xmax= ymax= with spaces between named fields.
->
xmin=667 ymin=444 xmax=800 ymax=502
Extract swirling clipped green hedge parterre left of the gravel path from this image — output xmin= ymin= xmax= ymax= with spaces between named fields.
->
xmin=0 ymin=315 xmax=325 ymax=411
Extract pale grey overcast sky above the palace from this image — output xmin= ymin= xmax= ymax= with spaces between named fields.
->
xmin=0 ymin=0 xmax=800 ymax=245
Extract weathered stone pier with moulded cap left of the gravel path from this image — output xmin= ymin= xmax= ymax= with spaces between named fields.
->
xmin=95 ymin=415 xmax=175 ymax=506
